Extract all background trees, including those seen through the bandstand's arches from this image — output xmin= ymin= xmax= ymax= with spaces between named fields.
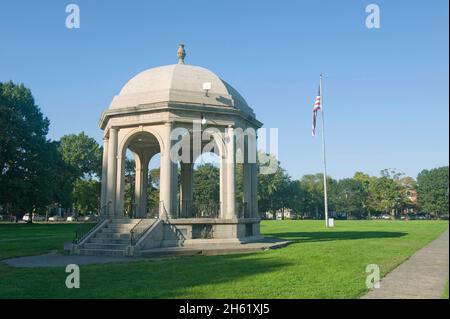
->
xmin=0 ymin=82 xmax=449 ymax=222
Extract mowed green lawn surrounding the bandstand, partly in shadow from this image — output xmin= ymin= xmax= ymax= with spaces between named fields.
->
xmin=0 ymin=221 xmax=448 ymax=298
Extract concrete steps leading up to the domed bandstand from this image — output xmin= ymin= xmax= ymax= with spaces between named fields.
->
xmin=78 ymin=219 xmax=140 ymax=257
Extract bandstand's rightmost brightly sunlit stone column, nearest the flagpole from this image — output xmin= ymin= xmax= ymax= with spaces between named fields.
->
xmin=225 ymin=125 xmax=236 ymax=219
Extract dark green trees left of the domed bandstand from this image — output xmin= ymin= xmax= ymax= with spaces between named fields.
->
xmin=0 ymin=82 xmax=102 ymax=221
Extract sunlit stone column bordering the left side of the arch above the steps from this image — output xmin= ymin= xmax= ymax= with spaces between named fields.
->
xmin=106 ymin=127 xmax=117 ymax=217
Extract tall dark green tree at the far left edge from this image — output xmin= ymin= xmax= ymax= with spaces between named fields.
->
xmin=0 ymin=82 xmax=59 ymax=219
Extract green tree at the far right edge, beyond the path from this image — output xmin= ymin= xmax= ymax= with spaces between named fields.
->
xmin=417 ymin=166 xmax=449 ymax=218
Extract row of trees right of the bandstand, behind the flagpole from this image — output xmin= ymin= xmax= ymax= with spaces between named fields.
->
xmin=258 ymin=155 xmax=449 ymax=219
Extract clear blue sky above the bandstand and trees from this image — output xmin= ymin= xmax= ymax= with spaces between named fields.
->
xmin=0 ymin=0 xmax=449 ymax=178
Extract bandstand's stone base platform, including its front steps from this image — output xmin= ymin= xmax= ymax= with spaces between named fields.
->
xmin=70 ymin=218 xmax=289 ymax=257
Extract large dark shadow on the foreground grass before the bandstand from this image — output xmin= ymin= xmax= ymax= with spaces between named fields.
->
xmin=0 ymin=254 xmax=291 ymax=298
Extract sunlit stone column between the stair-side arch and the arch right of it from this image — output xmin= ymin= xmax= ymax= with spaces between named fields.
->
xmin=159 ymin=122 xmax=178 ymax=218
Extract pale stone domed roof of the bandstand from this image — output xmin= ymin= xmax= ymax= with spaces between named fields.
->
xmin=110 ymin=62 xmax=255 ymax=117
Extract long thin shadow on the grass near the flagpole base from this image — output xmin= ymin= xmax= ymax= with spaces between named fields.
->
xmin=265 ymin=231 xmax=408 ymax=243
